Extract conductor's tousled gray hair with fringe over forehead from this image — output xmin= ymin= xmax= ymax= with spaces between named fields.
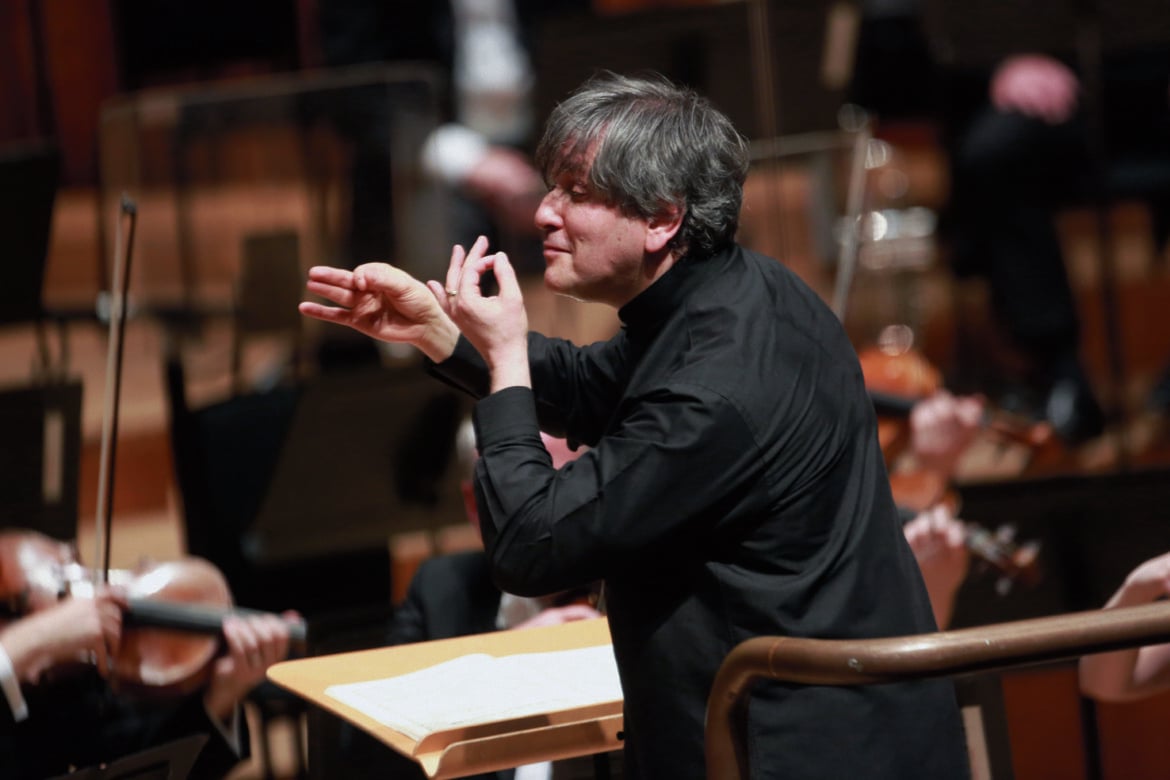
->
xmin=536 ymin=71 xmax=749 ymax=256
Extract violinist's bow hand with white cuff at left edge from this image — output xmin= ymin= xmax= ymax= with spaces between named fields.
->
xmin=0 ymin=587 xmax=126 ymax=683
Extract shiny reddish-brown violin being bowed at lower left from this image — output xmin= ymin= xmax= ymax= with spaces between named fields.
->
xmin=0 ymin=530 xmax=307 ymax=696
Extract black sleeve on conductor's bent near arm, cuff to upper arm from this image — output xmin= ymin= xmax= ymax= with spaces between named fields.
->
xmin=475 ymin=386 xmax=764 ymax=595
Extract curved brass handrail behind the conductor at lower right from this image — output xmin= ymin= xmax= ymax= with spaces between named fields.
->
xmin=706 ymin=602 xmax=1170 ymax=780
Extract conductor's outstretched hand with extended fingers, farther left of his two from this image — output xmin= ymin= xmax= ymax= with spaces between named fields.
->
xmin=300 ymin=263 xmax=459 ymax=363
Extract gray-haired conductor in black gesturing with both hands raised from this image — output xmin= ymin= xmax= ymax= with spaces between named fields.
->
xmin=301 ymin=74 xmax=968 ymax=780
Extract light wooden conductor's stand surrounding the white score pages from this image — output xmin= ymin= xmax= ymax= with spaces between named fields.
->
xmin=268 ymin=617 xmax=622 ymax=780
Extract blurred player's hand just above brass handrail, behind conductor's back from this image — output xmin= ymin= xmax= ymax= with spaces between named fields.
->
xmin=902 ymin=504 xmax=971 ymax=628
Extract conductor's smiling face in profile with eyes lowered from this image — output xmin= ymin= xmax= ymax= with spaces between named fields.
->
xmin=536 ymin=152 xmax=648 ymax=306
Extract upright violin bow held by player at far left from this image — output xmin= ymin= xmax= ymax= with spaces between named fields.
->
xmin=94 ymin=194 xmax=138 ymax=582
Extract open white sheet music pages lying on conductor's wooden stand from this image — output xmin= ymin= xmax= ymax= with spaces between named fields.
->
xmin=325 ymin=644 xmax=622 ymax=741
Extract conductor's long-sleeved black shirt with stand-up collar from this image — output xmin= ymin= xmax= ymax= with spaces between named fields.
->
xmin=433 ymin=247 xmax=966 ymax=780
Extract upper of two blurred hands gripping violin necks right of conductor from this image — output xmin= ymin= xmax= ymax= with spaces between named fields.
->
xmin=910 ymin=391 xmax=985 ymax=477
